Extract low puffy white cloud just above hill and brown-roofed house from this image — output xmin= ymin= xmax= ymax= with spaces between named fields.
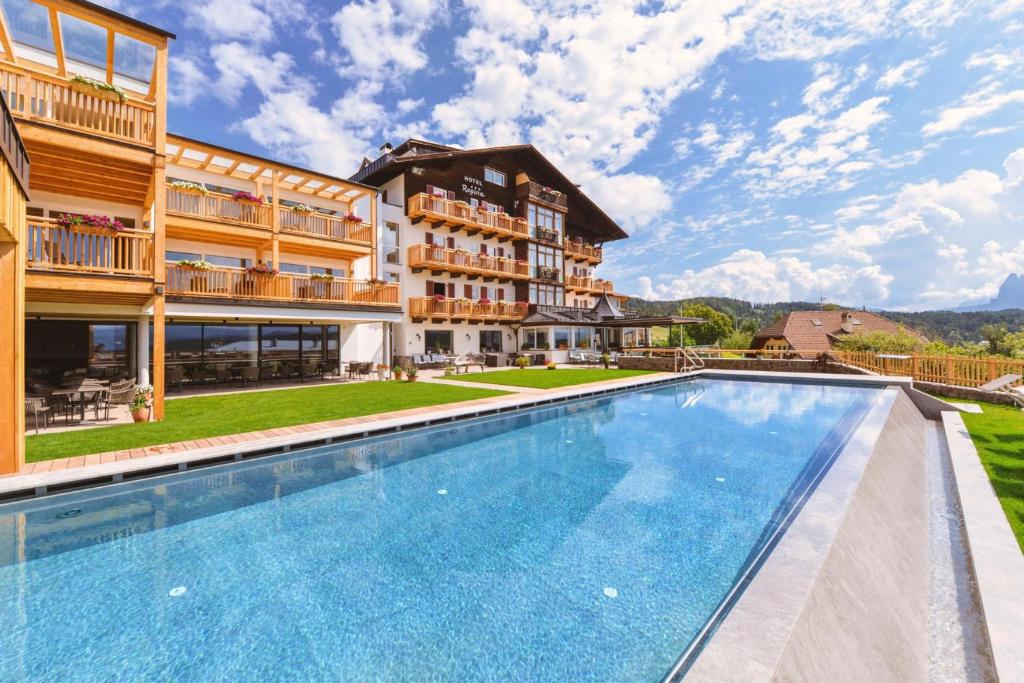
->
xmin=638 ymin=249 xmax=893 ymax=304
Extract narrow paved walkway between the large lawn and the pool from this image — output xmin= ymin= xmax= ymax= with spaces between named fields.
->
xmin=8 ymin=373 xmax=676 ymax=494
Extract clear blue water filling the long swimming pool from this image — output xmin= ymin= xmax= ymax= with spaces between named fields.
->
xmin=0 ymin=380 xmax=879 ymax=681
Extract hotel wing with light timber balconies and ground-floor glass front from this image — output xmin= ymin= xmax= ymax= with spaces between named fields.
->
xmin=0 ymin=0 xmax=401 ymax=473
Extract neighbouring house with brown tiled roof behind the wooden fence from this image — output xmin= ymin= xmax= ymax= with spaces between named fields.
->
xmin=751 ymin=310 xmax=928 ymax=358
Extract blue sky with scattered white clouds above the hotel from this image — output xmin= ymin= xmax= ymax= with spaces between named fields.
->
xmin=97 ymin=0 xmax=1024 ymax=309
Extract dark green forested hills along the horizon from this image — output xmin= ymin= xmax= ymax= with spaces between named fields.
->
xmin=626 ymin=297 xmax=1024 ymax=344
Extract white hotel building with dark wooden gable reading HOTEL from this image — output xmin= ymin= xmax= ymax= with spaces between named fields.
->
xmin=352 ymin=139 xmax=645 ymax=360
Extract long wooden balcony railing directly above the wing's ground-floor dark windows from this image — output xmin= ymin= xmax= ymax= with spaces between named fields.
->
xmin=167 ymin=263 xmax=398 ymax=306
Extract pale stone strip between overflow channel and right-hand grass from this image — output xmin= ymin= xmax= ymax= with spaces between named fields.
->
xmin=941 ymin=413 xmax=1024 ymax=681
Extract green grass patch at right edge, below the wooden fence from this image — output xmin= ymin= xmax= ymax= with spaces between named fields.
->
xmin=945 ymin=398 xmax=1024 ymax=551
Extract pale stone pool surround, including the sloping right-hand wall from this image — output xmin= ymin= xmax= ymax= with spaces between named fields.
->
xmin=0 ymin=370 xmax=1024 ymax=681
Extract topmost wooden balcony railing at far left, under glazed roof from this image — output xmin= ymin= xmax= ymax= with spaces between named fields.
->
xmin=0 ymin=66 xmax=157 ymax=147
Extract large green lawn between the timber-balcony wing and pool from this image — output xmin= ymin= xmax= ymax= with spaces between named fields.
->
xmin=25 ymin=382 xmax=504 ymax=463
